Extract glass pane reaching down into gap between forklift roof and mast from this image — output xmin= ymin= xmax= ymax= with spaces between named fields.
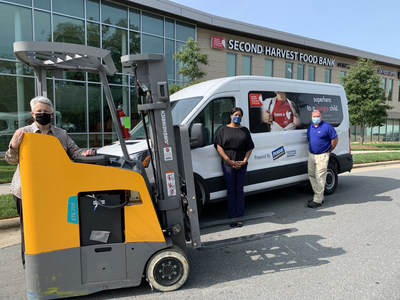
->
xmin=102 ymin=25 xmax=128 ymax=72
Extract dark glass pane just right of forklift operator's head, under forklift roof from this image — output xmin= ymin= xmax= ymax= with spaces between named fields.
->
xmin=55 ymin=80 xmax=87 ymax=132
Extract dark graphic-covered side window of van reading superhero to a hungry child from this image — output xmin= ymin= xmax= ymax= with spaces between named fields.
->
xmin=248 ymin=91 xmax=343 ymax=133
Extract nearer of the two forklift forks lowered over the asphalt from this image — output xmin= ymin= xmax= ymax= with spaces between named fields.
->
xmin=197 ymin=228 xmax=297 ymax=250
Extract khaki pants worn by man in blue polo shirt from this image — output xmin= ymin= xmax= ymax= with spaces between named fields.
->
xmin=308 ymin=152 xmax=330 ymax=204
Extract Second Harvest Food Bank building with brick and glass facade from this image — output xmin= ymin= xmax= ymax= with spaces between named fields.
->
xmin=0 ymin=0 xmax=400 ymax=152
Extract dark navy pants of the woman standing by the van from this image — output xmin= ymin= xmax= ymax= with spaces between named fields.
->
xmin=222 ymin=163 xmax=247 ymax=218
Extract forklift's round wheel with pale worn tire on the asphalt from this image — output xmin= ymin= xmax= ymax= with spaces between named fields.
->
xmin=146 ymin=246 xmax=189 ymax=292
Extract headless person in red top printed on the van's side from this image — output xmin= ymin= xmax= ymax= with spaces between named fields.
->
xmin=261 ymin=92 xmax=300 ymax=131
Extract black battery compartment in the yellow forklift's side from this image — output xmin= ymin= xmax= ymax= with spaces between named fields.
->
xmin=78 ymin=190 xmax=125 ymax=246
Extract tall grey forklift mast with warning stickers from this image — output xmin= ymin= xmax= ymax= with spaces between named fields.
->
xmin=121 ymin=54 xmax=200 ymax=249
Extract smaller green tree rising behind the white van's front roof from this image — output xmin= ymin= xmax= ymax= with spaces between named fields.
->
xmin=173 ymin=37 xmax=208 ymax=83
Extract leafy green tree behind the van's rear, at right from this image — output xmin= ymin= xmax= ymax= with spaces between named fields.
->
xmin=343 ymin=58 xmax=392 ymax=145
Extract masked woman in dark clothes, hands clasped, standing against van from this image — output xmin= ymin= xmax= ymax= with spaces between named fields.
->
xmin=214 ymin=107 xmax=254 ymax=227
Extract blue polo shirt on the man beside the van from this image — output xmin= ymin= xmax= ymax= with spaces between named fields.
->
xmin=307 ymin=121 xmax=337 ymax=154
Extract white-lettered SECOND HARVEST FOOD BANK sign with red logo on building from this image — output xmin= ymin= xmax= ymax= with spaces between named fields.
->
xmin=211 ymin=36 xmax=335 ymax=67
